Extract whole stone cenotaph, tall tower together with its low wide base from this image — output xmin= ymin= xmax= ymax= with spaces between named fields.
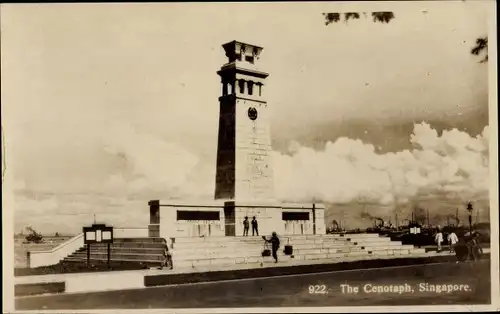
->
xmin=149 ymin=41 xmax=326 ymax=239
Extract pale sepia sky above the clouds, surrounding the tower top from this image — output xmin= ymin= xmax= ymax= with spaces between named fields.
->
xmin=0 ymin=1 xmax=488 ymax=233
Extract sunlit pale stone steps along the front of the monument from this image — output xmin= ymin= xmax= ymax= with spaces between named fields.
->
xmin=172 ymin=233 xmax=425 ymax=268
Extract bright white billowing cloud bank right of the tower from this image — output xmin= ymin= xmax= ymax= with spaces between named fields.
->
xmin=274 ymin=123 xmax=489 ymax=204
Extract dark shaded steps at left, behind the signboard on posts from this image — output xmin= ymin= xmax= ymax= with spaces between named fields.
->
xmin=62 ymin=238 xmax=166 ymax=268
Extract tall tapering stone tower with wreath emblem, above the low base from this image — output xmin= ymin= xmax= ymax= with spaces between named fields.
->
xmin=215 ymin=41 xmax=274 ymax=200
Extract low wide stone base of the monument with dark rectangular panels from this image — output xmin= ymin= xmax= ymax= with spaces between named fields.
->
xmin=149 ymin=200 xmax=326 ymax=240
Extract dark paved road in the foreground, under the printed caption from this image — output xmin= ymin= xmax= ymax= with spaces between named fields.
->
xmin=16 ymin=260 xmax=491 ymax=310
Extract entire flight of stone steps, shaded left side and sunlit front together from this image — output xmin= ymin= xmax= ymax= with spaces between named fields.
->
xmin=55 ymin=233 xmax=425 ymax=269
